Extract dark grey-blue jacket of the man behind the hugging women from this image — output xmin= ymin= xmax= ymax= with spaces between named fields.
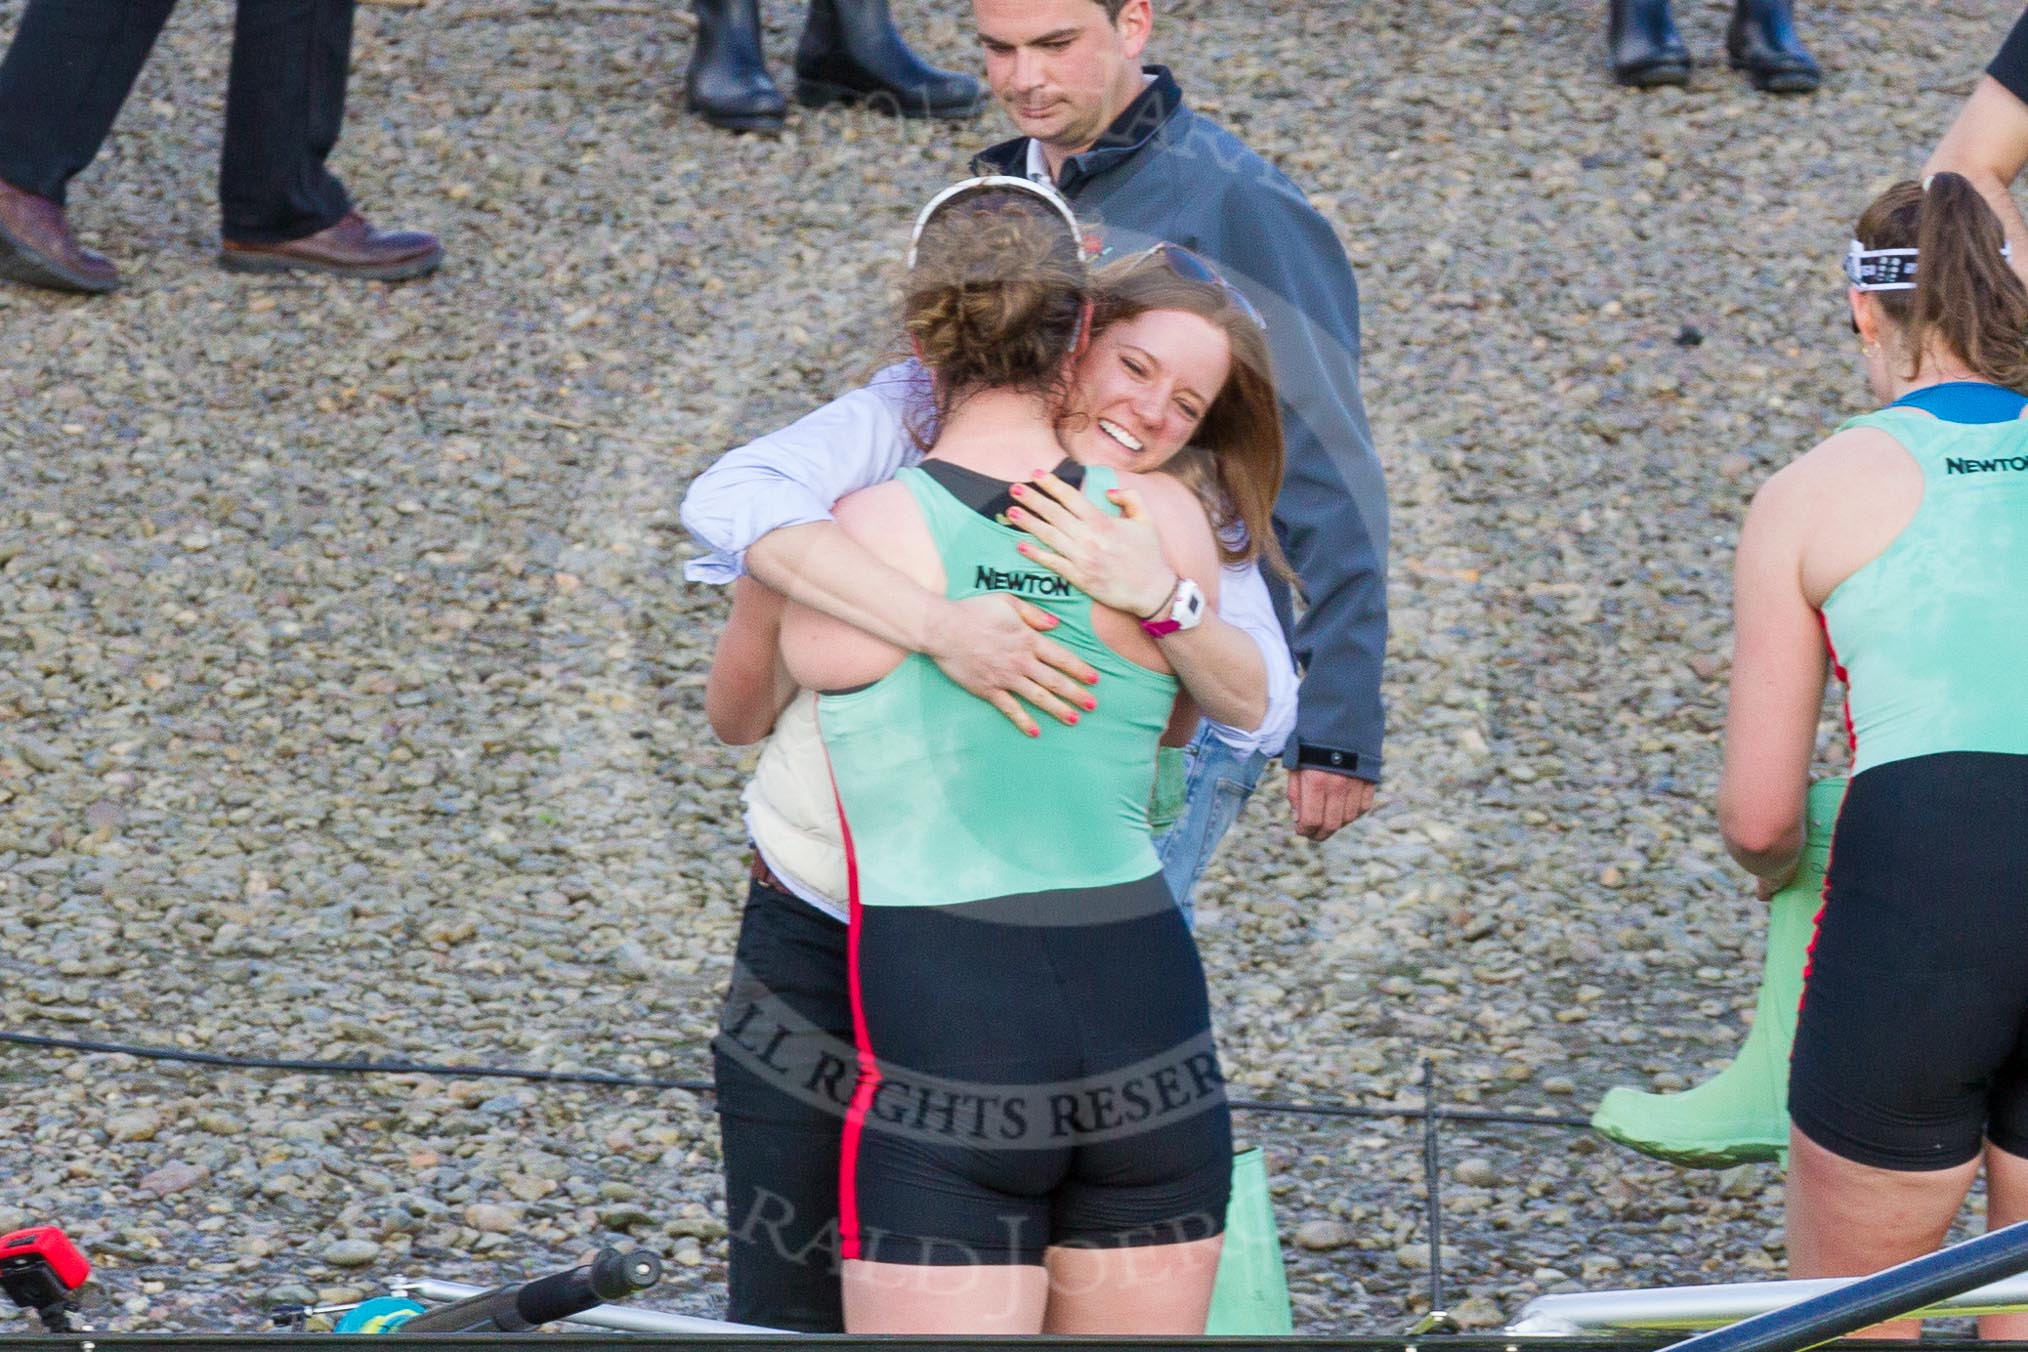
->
xmin=973 ymin=65 xmax=1387 ymax=780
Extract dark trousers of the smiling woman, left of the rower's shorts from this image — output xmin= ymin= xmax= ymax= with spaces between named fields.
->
xmin=712 ymin=882 xmax=856 ymax=1334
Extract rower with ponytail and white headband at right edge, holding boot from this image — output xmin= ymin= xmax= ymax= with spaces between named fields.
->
xmin=1718 ymin=174 xmax=2028 ymax=1338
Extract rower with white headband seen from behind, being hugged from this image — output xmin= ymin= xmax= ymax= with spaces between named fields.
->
xmin=766 ymin=186 xmax=1280 ymax=1334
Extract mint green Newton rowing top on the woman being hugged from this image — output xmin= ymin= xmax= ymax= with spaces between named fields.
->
xmin=817 ymin=468 xmax=1176 ymax=906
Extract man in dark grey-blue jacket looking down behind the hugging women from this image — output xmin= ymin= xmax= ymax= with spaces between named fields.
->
xmin=973 ymin=0 xmax=1387 ymax=843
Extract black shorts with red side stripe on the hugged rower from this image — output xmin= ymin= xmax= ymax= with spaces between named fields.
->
xmin=840 ymin=874 xmax=1233 ymax=1265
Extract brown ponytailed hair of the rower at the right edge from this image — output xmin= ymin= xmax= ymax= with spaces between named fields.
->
xmin=1854 ymin=174 xmax=2028 ymax=393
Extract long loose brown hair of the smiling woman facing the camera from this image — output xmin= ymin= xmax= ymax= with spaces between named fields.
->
xmin=1091 ymin=253 xmax=1296 ymax=582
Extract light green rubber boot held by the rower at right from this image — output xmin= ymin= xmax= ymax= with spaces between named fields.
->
xmin=1592 ymin=778 xmax=1845 ymax=1170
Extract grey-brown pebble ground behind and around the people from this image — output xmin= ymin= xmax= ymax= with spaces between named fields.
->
xmin=0 ymin=0 xmax=2018 ymax=1332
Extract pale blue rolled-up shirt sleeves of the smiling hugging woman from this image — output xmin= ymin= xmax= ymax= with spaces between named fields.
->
xmin=683 ymin=361 xmax=1296 ymax=756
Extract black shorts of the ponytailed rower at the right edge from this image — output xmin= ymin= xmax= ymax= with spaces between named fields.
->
xmin=1789 ymin=752 xmax=2028 ymax=1172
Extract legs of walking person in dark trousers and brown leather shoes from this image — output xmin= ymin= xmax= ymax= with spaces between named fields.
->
xmin=0 ymin=0 xmax=444 ymax=292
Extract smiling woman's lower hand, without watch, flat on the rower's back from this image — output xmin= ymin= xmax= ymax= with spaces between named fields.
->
xmin=923 ymin=596 xmax=1099 ymax=738
